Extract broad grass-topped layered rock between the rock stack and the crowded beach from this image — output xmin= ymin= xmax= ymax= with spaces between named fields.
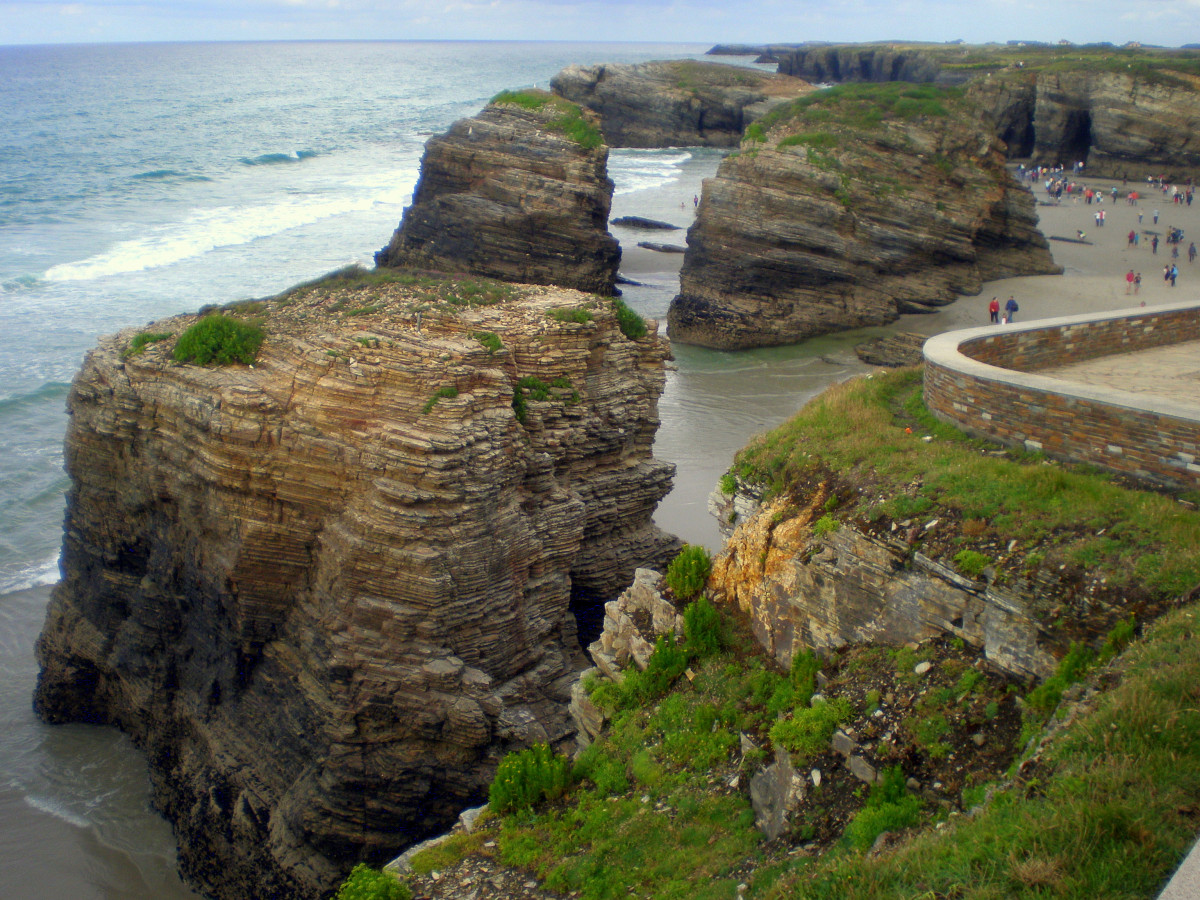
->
xmin=668 ymin=85 xmax=1058 ymax=349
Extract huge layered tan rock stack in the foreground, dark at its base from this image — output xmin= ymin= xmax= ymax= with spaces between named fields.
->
xmin=36 ymin=280 xmax=678 ymax=900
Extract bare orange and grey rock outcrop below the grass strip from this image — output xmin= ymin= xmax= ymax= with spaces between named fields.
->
xmin=709 ymin=492 xmax=1066 ymax=678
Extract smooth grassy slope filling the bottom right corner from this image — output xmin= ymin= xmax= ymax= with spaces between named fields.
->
xmin=751 ymin=605 xmax=1200 ymax=900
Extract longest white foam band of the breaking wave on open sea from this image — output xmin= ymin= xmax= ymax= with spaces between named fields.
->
xmin=43 ymin=169 xmax=416 ymax=282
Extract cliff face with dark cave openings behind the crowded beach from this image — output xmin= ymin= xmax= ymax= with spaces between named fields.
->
xmin=971 ymin=71 xmax=1200 ymax=178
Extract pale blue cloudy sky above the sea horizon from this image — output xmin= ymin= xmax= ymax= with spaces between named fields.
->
xmin=0 ymin=0 xmax=1200 ymax=47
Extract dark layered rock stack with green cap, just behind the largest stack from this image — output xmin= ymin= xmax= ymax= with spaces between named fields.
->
xmin=376 ymin=97 xmax=620 ymax=295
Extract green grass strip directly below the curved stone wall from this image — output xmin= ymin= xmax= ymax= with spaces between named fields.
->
xmin=733 ymin=370 xmax=1200 ymax=599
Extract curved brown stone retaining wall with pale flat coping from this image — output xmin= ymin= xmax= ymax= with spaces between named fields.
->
xmin=924 ymin=301 xmax=1200 ymax=488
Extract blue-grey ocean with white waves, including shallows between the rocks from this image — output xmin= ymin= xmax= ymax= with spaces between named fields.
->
xmin=0 ymin=42 xmax=863 ymax=900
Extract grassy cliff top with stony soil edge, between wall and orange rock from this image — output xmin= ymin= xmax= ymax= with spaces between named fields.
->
xmin=733 ymin=370 xmax=1200 ymax=640
